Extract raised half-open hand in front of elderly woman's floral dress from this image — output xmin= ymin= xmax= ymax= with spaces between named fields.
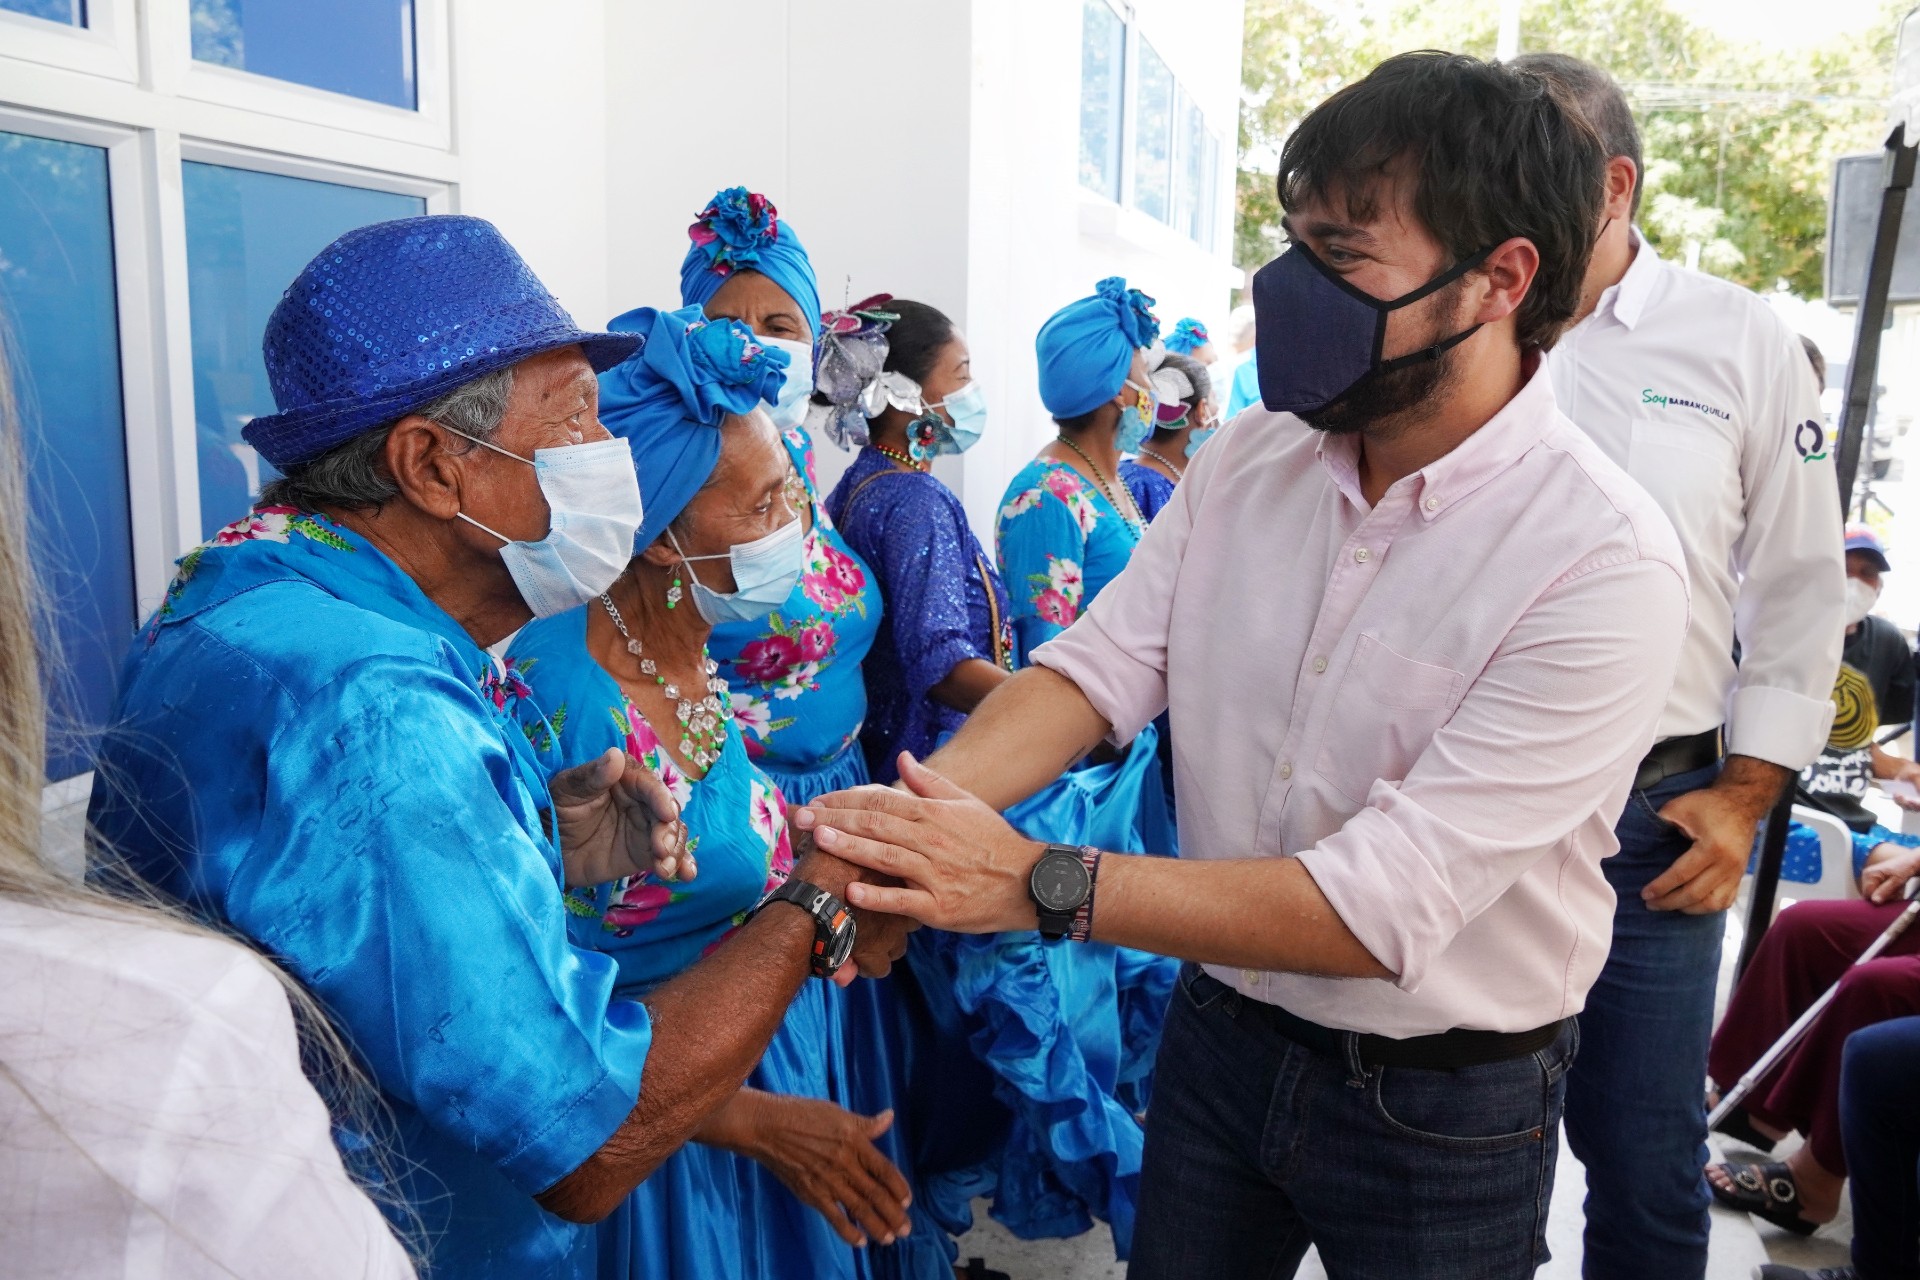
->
xmin=547 ymin=747 xmax=699 ymax=887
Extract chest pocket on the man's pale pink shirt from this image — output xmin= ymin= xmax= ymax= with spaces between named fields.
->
xmin=1313 ymin=635 xmax=1467 ymax=804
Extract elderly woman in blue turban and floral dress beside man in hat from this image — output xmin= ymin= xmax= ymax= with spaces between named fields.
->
xmin=509 ymin=307 xmax=908 ymax=1280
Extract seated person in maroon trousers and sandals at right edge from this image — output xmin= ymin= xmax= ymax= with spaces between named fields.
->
xmin=1707 ymin=846 xmax=1920 ymax=1236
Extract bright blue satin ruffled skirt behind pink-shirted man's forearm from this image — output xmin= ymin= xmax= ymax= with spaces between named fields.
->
xmin=908 ymin=729 xmax=1179 ymax=1259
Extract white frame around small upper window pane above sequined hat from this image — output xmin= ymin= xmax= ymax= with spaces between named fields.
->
xmin=146 ymin=0 xmax=453 ymax=150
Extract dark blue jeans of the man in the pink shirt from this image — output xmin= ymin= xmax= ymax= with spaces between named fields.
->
xmin=1127 ymin=965 xmax=1578 ymax=1280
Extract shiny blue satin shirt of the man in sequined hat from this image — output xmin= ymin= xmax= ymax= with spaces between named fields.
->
xmin=90 ymin=507 xmax=653 ymax=1280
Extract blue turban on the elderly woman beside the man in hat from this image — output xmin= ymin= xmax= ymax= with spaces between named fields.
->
xmin=601 ymin=307 xmax=787 ymax=555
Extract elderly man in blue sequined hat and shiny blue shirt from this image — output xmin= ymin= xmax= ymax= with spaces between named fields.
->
xmin=92 ymin=217 xmax=899 ymax=1280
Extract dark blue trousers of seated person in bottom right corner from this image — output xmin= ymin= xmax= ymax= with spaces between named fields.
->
xmin=1839 ymin=1017 xmax=1920 ymax=1280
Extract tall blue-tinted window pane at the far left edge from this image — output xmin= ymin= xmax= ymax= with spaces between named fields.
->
xmin=0 ymin=132 xmax=134 ymax=781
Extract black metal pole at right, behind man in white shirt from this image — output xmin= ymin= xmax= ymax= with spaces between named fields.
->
xmin=1734 ymin=125 xmax=1914 ymax=981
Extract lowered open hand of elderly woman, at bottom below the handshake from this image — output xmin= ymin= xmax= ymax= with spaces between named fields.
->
xmin=695 ymin=1088 xmax=914 ymax=1247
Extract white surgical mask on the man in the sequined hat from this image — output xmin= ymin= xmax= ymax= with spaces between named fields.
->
xmin=442 ymin=422 xmax=641 ymax=618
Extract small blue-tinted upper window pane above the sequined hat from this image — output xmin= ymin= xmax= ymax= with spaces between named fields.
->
xmin=191 ymin=0 xmax=417 ymax=111
